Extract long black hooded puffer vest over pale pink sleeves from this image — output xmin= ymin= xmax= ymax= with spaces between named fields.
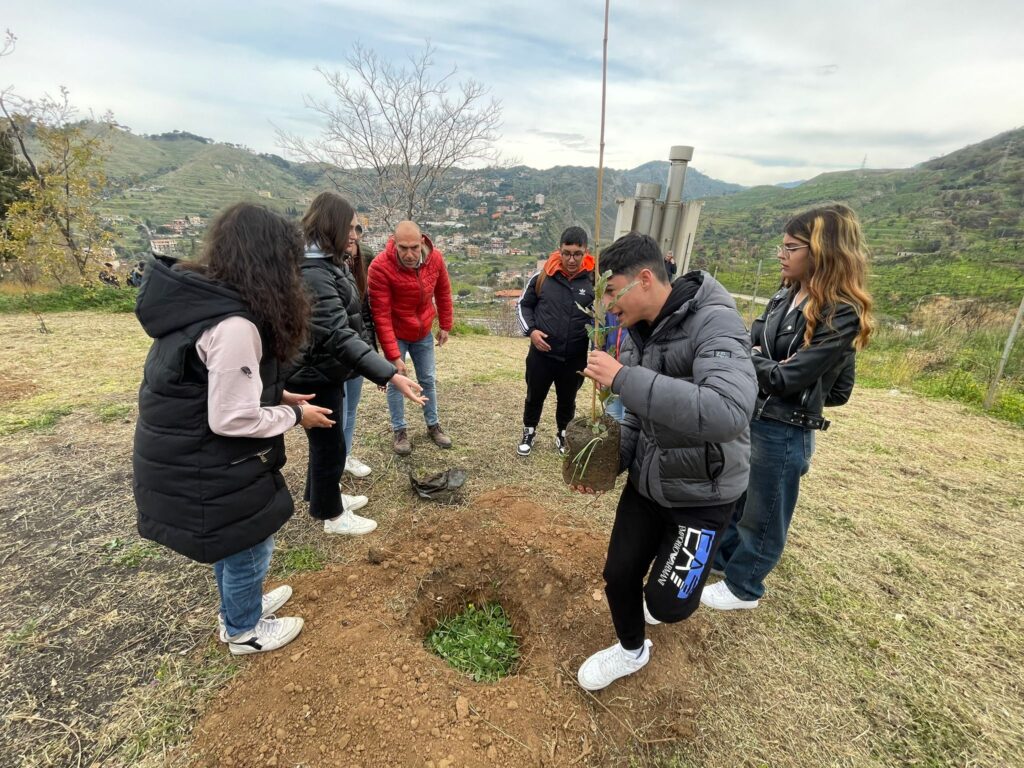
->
xmin=133 ymin=260 xmax=295 ymax=562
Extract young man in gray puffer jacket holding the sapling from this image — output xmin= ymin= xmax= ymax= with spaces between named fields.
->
xmin=577 ymin=232 xmax=757 ymax=690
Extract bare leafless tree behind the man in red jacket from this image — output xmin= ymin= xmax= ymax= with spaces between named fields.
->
xmin=278 ymin=41 xmax=502 ymax=225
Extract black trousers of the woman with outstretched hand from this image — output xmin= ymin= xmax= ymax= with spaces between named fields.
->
xmin=302 ymin=384 xmax=345 ymax=520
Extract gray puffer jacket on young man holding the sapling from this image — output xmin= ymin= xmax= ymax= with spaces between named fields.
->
xmin=611 ymin=271 xmax=758 ymax=507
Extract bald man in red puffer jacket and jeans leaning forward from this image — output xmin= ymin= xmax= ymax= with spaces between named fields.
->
xmin=368 ymin=221 xmax=453 ymax=456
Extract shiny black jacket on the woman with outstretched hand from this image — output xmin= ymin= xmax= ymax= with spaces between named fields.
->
xmin=288 ymin=257 xmax=397 ymax=392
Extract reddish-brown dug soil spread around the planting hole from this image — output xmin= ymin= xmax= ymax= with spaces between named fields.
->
xmin=194 ymin=488 xmax=703 ymax=768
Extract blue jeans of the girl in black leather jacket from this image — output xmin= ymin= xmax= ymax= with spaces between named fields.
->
xmin=715 ymin=419 xmax=814 ymax=600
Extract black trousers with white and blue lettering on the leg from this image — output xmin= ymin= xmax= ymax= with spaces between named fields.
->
xmin=604 ymin=482 xmax=733 ymax=650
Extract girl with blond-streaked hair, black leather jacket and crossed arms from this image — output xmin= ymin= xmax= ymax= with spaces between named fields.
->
xmin=701 ymin=205 xmax=873 ymax=610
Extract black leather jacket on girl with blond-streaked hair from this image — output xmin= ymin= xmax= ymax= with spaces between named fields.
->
xmin=751 ymin=288 xmax=860 ymax=429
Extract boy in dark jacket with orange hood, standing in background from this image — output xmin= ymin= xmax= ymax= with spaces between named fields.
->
xmin=517 ymin=226 xmax=594 ymax=456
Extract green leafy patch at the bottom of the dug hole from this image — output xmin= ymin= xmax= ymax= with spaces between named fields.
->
xmin=425 ymin=601 xmax=519 ymax=683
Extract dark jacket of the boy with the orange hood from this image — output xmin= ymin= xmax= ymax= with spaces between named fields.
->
xmin=518 ymin=269 xmax=594 ymax=360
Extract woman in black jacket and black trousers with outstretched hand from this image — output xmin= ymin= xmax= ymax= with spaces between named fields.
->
xmin=288 ymin=191 xmax=426 ymax=536
